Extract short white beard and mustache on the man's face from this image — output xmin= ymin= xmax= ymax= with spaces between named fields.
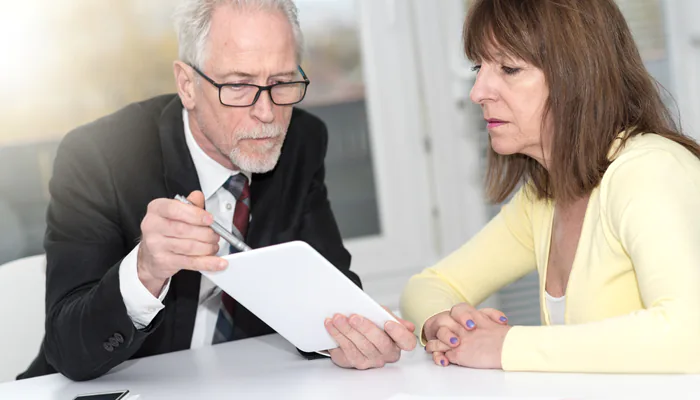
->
xmin=229 ymin=124 xmax=286 ymax=174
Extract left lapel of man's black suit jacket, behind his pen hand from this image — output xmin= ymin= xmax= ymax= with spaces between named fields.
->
xmin=158 ymin=96 xmax=202 ymax=350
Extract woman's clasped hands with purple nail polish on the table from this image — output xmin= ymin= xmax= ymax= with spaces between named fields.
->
xmin=423 ymin=303 xmax=510 ymax=368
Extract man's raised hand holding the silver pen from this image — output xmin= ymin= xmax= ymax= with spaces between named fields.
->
xmin=137 ymin=191 xmax=228 ymax=297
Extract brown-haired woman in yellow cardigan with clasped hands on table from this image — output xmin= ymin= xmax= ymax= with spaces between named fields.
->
xmin=401 ymin=0 xmax=700 ymax=373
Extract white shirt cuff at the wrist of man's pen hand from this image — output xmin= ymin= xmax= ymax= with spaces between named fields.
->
xmin=119 ymin=245 xmax=170 ymax=329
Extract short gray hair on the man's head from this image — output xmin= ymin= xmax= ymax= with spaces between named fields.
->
xmin=175 ymin=0 xmax=304 ymax=68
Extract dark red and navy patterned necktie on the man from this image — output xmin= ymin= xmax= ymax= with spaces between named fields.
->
xmin=212 ymin=173 xmax=250 ymax=344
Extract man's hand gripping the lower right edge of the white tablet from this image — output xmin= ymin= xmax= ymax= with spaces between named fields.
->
xmin=325 ymin=307 xmax=416 ymax=369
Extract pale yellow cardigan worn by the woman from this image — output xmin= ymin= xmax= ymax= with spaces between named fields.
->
xmin=401 ymin=134 xmax=700 ymax=373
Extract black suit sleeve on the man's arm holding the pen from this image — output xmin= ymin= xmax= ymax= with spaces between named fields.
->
xmin=43 ymin=131 xmax=163 ymax=380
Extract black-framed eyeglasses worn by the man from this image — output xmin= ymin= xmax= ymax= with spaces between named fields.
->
xmin=190 ymin=65 xmax=311 ymax=107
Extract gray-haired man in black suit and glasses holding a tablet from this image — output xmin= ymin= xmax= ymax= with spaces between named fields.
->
xmin=20 ymin=0 xmax=416 ymax=380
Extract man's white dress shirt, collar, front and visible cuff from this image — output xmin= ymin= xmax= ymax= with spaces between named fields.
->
xmin=119 ymin=109 xmax=251 ymax=348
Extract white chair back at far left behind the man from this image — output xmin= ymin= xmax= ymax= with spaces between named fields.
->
xmin=0 ymin=254 xmax=46 ymax=383
